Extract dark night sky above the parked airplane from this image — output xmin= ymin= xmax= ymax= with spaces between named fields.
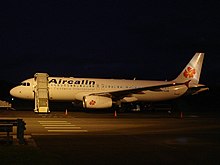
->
xmin=0 ymin=0 xmax=220 ymax=84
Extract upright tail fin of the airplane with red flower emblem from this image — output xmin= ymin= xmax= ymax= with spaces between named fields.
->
xmin=174 ymin=53 xmax=204 ymax=84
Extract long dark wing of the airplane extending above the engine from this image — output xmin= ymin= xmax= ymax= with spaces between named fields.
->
xmin=90 ymin=82 xmax=188 ymax=100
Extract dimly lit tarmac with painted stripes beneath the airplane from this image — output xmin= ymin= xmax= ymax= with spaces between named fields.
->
xmin=0 ymin=110 xmax=220 ymax=165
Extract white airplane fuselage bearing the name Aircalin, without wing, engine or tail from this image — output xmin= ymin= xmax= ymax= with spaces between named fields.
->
xmin=10 ymin=77 xmax=188 ymax=102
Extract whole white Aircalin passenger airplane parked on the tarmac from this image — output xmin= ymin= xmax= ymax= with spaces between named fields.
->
xmin=10 ymin=53 xmax=208 ymax=109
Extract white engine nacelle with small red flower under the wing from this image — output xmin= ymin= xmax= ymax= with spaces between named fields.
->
xmin=83 ymin=96 xmax=112 ymax=109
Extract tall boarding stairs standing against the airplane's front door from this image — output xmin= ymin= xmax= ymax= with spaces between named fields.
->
xmin=34 ymin=73 xmax=50 ymax=113
